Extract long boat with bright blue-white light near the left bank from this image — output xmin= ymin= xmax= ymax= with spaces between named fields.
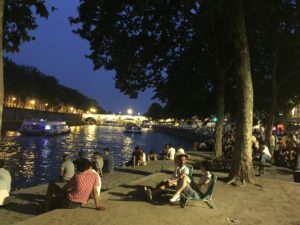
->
xmin=19 ymin=119 xmax=71 ymax=136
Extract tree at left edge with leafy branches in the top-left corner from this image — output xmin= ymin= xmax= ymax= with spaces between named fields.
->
xmin=0 ymin=0 xmax=49 ymax=138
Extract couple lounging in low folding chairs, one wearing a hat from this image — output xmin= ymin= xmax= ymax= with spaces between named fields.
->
xmin=145 ymin=153 xmax=211 ymax=203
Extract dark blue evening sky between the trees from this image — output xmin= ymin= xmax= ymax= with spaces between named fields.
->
xmin=7 ymin=0 xmax=156 ymax=114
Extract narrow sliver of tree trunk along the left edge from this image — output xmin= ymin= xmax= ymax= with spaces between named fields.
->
xmin=0 ymin=0 xmax=4 ymax=140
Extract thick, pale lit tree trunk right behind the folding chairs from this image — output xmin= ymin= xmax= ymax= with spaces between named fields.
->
xmin=228 ymin=0 xmax=255 ymax=184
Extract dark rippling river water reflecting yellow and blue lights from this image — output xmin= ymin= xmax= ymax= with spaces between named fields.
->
xmin=0 ymin=126 xmax=191 ymax=190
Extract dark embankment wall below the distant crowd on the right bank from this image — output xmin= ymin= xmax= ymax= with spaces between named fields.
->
xmin=152 ymin=126 xmax=212 ymax=142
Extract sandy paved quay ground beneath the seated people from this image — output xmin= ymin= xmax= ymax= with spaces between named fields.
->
xmin=0 ymin=152 xmax=300 ymax=225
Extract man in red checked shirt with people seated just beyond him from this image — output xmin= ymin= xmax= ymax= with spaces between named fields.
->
xmin=44 ymin=148 xmax=114 ymax=212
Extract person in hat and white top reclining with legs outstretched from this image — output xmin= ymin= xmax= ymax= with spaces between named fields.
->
xmin=144 ymin=153 xmax=191 ymax=202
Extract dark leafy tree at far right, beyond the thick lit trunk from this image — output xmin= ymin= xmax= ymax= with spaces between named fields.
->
xmin=248 ymin=0 xmax=300 ymax=152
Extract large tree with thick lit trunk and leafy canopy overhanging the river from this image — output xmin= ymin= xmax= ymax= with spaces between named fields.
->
xmin=70 ymin=0 xmax=254 ymax=183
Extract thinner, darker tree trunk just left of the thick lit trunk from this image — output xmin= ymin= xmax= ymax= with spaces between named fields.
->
xmin=215 ymin=68 xmax=225 ymax=158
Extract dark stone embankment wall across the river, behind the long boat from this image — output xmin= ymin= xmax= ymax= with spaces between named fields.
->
xmin=2 ymin=107 xmax=84 ymax=129
